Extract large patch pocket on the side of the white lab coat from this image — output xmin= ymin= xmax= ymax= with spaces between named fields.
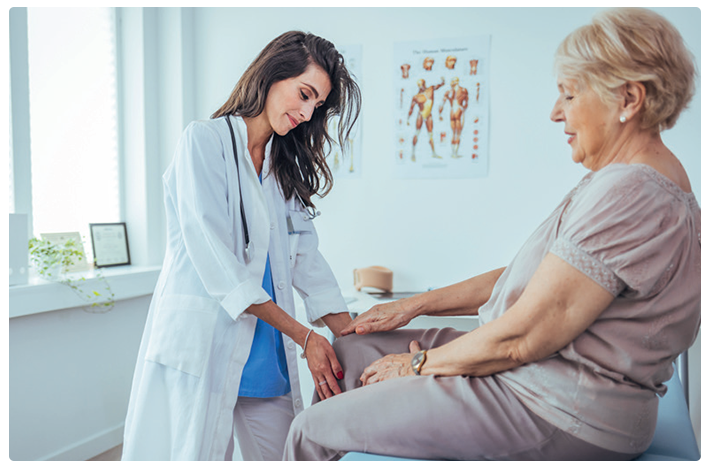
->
xmin=145 ymin=294 xmax=219 ymax=377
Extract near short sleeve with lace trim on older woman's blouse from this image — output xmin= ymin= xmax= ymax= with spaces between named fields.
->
xmin=551 ymin=164 xmax=696 ymax=297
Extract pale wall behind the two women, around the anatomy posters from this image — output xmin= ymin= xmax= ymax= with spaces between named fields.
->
xmin=185 ymin=4 xmax=701 ymax=446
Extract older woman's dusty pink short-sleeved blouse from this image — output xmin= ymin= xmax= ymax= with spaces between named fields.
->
xmin=480 ymin=164 xmax=701 ymax=453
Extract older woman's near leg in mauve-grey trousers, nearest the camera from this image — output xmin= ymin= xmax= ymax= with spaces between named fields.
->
xmin=284 ymin=362 xmax=556 ymax=460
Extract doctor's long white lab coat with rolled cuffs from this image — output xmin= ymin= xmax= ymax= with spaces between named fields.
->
xmin=123 ymin=117 xmax=347 ymax=460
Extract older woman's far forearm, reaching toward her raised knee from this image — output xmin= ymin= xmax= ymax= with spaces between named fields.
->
xmin=410 ymin=268 xmax=505 ymax=316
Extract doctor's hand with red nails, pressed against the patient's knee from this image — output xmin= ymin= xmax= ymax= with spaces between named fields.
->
xmin=304 ymin=332 xmax=344 ymax=400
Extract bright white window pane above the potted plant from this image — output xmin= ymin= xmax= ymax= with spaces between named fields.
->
xmin=23 ymin=8 xmax=121 ymax=258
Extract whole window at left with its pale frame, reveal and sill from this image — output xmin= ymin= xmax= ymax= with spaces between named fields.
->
xmin=9 ymin=7 xmax=167 ymax=318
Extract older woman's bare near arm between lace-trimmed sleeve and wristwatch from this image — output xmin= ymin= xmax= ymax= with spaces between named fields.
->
xmin=421 ymin=254 xmax=615 ymax=377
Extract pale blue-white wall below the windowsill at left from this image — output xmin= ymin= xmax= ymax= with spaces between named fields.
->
xmin=9 ymin=296 xmax=151 ymax=460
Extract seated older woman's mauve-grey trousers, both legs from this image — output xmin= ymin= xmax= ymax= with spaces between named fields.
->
xmin=284 ymin=328 xmax=639 ymax=460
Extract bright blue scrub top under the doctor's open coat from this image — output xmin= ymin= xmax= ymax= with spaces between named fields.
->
xmin=239 ymin=176 xmax=290 ymax=398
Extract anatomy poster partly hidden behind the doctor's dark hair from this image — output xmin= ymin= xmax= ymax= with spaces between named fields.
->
xmin=325 ymin=45 xmax=362 ymax=178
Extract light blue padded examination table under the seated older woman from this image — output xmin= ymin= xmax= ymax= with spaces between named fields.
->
xmin=342 ymin=362 xmax=700 ymax=461
